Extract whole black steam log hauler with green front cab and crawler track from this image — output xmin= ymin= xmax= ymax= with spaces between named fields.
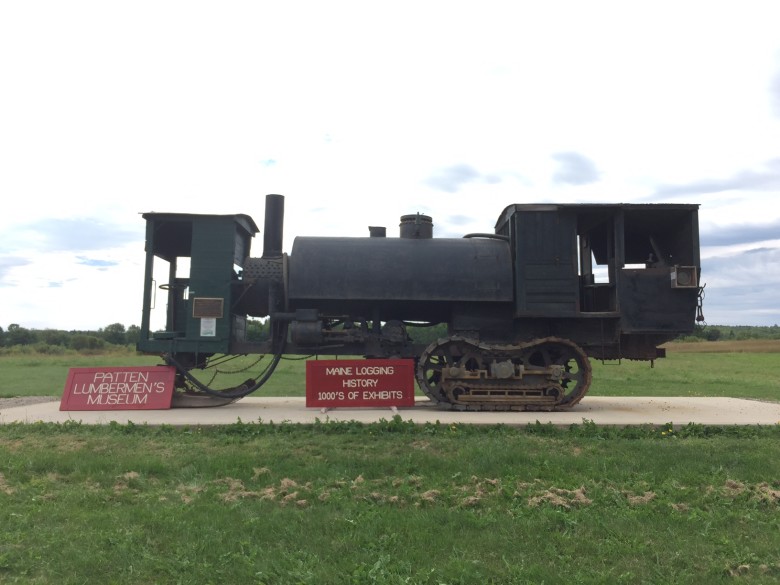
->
xmin=138 ymin=195 xmax=702 ymax=410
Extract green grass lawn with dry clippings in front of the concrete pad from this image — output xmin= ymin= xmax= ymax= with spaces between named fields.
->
xmin=0 ymin=419 xmax=780 ymax=585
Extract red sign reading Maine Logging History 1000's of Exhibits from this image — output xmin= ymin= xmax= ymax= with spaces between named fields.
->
xmin=306 ymin=360 xmax=414 ymax=408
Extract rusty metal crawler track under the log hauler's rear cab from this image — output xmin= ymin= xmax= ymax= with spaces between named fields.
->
xmin=417 ymin=336 xmax=591 ymax=411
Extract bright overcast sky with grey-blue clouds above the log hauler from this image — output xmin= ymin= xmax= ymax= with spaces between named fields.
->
xmin=0 ymin=0 xmax=780 ymax=329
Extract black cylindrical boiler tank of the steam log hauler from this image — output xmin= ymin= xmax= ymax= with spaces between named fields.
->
xmin=288 ymin=237 xmax=513 ymax=319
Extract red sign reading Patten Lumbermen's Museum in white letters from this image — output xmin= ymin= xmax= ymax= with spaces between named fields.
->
xmin=60 ymin=366 xmax=176 ymax=410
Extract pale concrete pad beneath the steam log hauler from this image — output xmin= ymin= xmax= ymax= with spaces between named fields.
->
xmin=0 ymin=396 xmax=780 ymax=426
